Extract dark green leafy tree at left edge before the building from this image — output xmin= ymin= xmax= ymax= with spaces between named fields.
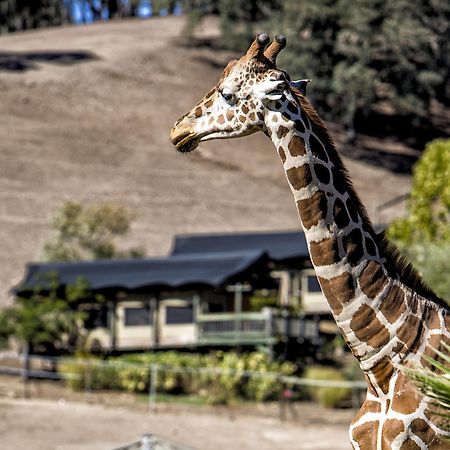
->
xmin=0 ymin=274 xmax=96 ymax=353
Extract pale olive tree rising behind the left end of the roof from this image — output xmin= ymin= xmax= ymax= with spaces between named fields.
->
xmin=44 ymin=202 xmax=144 ymax=261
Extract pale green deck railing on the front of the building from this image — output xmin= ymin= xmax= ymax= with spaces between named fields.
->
xmin=197 ymin=309 xmax=273 ymax=344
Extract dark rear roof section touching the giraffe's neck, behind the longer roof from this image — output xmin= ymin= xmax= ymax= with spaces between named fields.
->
xmin=172 ymin=231 xmax=309 ymax=261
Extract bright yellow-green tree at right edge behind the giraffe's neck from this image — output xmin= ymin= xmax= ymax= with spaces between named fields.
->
xmin=388 ymin=139 xmax=450 ymax=301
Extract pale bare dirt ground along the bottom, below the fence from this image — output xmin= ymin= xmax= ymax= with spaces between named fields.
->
xmin=0 ymin=377 xmax=353 ymax=450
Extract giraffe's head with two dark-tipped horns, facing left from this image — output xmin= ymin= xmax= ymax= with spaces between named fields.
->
xmin=170 ymin=34 xmax=309 ymax=153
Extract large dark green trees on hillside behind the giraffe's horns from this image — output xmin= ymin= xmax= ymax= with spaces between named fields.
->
xmin=271 ymin=0 xmax=450 ymax=131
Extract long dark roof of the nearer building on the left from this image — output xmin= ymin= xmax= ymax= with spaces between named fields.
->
xmin=16 ymin=251 xmax=267 ymax=292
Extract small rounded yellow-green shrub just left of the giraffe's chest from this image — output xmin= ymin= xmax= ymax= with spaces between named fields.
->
xmin=304 ymin=366 xmax=351 ymax=408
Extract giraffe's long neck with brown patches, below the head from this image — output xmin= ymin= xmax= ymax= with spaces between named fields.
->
xmin=266 ymin=100 xmax=405 ymax=370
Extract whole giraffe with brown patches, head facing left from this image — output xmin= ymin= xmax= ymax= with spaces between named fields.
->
xmin=171 ymin=34 xmax=450 ymax=450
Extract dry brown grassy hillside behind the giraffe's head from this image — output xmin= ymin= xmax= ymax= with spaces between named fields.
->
xmin=0 ymin=17 xmax=410 ymax=304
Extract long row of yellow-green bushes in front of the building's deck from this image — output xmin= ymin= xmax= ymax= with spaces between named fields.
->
xmin=59 ymin=351 xmax=297 ymax=404
